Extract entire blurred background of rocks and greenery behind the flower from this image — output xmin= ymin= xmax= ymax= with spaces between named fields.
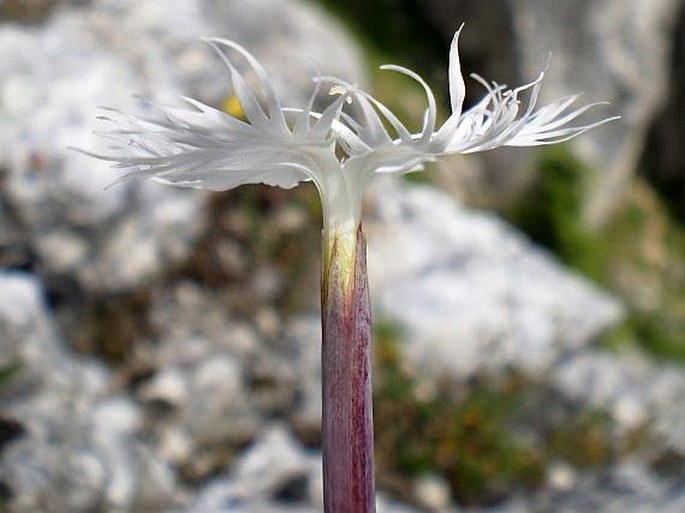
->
xmin=0 ymin=0 xmax=685 ymax=513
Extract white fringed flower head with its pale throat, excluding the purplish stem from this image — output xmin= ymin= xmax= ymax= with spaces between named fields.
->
xmin=88 ymin=29 xmax=616 ymax=242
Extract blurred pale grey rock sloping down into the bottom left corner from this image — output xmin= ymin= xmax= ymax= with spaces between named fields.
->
xmin=0 ymin=272 xmax=174 ymax=513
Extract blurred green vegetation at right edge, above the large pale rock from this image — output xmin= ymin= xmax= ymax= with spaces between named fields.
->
xmin=509 ymin=147 xmax=685 ymax=363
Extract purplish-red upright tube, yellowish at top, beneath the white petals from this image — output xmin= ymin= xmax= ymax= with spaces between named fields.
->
xmin=321 ymin=225 xmax=376 ymax=513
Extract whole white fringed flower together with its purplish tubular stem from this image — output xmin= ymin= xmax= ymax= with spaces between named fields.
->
xmin=85 ymin=29 xmax=616 ymax=513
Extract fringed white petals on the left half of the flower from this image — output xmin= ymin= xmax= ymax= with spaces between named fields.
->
xmin=84 ymin=39 xmax=342 ymax=190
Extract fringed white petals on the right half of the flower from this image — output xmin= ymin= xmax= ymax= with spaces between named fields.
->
xmin=329 ymin=28 xmax=618 ymax=166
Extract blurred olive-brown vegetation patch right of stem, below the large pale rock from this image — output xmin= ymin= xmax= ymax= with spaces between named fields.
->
xmin=374 ymin=323 xmax=623 ymax=505
